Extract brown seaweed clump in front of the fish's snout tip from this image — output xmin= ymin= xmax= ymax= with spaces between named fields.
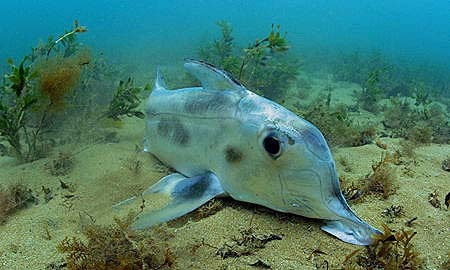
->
xmin=344 ymin=225 xmax=422 ymax=270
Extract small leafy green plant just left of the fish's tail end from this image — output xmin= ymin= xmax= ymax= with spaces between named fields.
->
xmin=105 ymin=78 xmax=149 ymax=121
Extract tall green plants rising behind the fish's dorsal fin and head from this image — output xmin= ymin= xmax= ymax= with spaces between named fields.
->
xmin=199 ymin=21 xmax=299 ymax=99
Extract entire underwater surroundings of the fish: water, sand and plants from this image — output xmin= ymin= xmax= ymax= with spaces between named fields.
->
xmin=0 ymin=0 xmax=450 ymax=269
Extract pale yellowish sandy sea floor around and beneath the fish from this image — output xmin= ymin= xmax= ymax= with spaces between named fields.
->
xmin=0 ymin=76 xmax=450 ymax=270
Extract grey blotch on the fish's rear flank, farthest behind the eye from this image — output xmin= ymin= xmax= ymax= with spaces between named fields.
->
xmin=157 ymin=117 xmax=190 ymax=146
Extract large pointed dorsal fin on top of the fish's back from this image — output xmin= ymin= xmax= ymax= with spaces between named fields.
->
xmin=184 ymin=59 xmax=245 ymax=91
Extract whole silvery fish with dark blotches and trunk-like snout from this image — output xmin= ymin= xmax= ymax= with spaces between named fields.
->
xmin=117 ymin=60 xmax=380 ymax=245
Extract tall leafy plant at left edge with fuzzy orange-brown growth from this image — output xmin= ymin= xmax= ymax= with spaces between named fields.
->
xmin=0 ymin=22 xmax=89 ymax=162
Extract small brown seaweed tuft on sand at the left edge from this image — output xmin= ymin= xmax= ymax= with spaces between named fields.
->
xmin=0 ymin=184 xmax=37 ymax=224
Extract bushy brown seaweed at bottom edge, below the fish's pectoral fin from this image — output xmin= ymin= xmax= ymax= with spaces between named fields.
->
xmin=57 ymin=215 xmax=176 ymax=270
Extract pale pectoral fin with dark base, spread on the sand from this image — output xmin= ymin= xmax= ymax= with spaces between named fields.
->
xmin=114 ymin=173 xmax=224 ymax=229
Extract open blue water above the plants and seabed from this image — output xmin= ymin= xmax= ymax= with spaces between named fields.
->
xmin=0 ymin=0 xmax=450 ymax=72
